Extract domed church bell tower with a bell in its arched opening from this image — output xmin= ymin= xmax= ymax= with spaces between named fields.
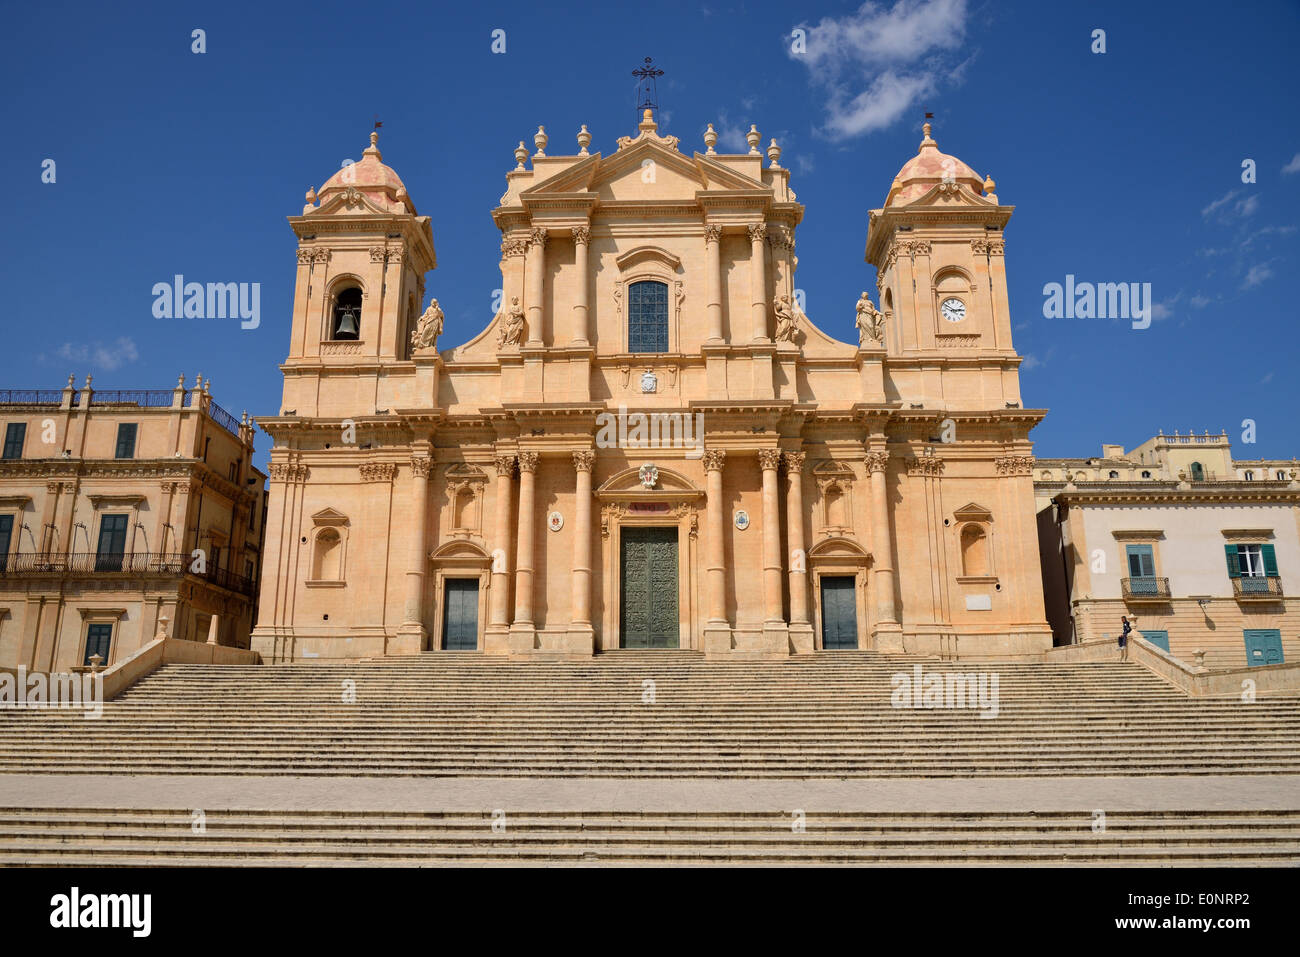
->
xmin=283 ymin=131 xmax=437 ymax=416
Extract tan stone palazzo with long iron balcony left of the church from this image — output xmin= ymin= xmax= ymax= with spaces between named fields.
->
xmin=0 ymin=376 xmax=267 ymax=671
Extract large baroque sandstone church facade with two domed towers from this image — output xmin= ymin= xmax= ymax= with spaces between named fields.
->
xmin=252 ymin=111 xmax=1052 ymax=662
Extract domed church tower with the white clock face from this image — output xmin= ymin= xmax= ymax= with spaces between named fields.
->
xmin=866 ymin=122 xmax=1021 ymax=408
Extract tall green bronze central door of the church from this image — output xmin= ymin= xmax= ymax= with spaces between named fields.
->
xmin=619 ymin=528 xmax=681 ymax=648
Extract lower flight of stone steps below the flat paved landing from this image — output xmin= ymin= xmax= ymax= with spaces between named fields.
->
xmin=0 ymin=809 xmax=1300 ymax=866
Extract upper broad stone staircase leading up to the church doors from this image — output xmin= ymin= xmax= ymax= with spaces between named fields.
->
xmin=0 ymin=651 xmax=1300 ymax=779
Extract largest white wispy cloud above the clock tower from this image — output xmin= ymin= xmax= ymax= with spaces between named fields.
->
xmin=787 ymin=0 xmax=967 ymax=139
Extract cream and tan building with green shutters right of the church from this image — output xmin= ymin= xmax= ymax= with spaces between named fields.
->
xmin=1035 ymin=432 xmax=1300 ymax=668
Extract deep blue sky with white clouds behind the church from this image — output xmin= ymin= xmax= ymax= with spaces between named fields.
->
xmin=0 ymin=0 xmax=1300 ymax=462
